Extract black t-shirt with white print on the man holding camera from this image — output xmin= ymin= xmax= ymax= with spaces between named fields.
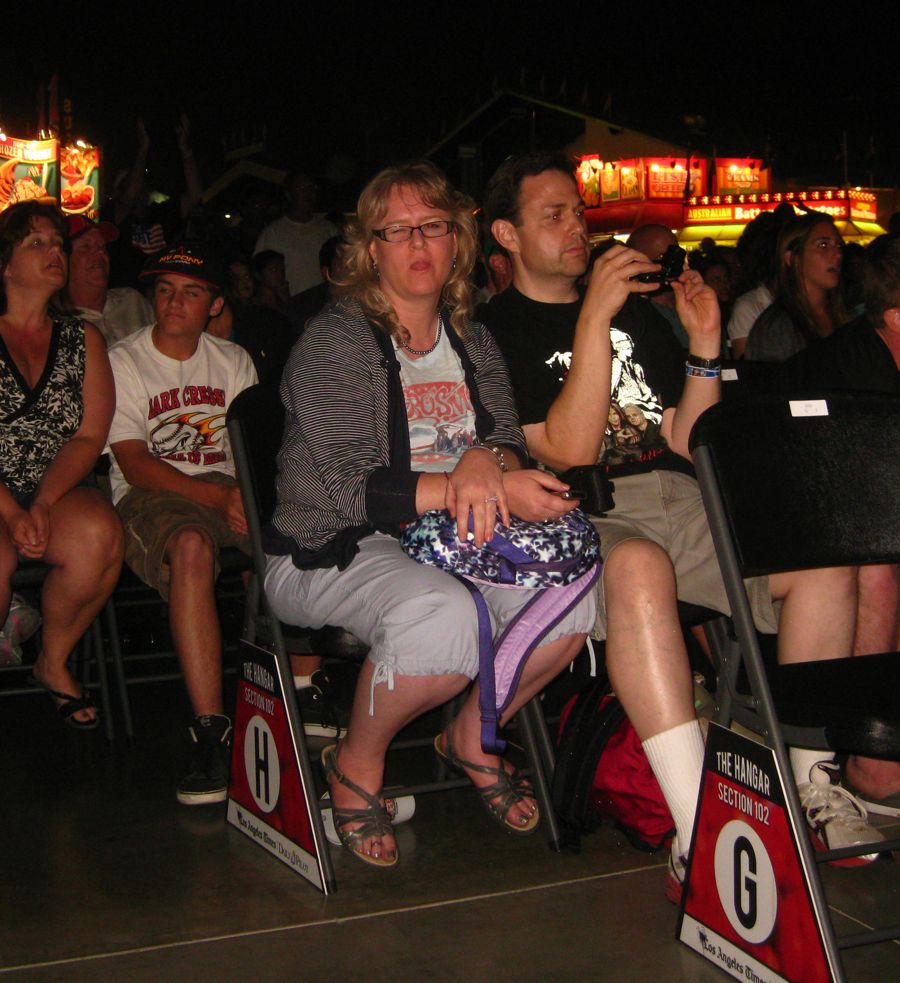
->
xmin=476 ymin=287 xmax=693 ymax=477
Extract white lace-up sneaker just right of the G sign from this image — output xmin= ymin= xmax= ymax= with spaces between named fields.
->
xmin=797 ymin=761 xmax=884 ymax=867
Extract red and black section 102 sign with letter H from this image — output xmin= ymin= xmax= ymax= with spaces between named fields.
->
xmin=228 ymin=642 xmax=330 ymax=894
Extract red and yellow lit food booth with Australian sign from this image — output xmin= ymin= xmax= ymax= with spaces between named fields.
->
xmin=576 ymin=154 xmax=884 ymax=249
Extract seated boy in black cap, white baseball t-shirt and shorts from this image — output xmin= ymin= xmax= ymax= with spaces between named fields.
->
xmin=109 ymin=245 xmax=258 ymax=805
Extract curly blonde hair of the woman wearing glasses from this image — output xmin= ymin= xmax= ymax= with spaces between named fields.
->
xmin=334 ymin=160 xmax=478 ymax=343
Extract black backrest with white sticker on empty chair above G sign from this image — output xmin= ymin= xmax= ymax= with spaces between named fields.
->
xmin=691 ymin=392 xmax=900 ymax=576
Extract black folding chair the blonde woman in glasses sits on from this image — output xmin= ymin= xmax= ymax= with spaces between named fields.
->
xmin=228 ymin=385 xmax=560 ymax=850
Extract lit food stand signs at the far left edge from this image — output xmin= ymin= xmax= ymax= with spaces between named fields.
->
xmin=0 ymin=134 xmax=101 ymax=220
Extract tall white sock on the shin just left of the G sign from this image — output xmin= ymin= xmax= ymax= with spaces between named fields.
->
xmin=642 ymin=720 xmax=704 ymax=856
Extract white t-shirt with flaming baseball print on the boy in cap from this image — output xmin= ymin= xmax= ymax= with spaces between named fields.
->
xmin=109 ymin=327 xmax=260 ymax=502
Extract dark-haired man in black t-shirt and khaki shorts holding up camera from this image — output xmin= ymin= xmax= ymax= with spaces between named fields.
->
xmin=479 ymin=153 xmax=880 ymax=900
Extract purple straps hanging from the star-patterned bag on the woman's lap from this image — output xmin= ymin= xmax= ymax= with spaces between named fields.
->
xmin=459 ymin=565 xmax=600 ymax=754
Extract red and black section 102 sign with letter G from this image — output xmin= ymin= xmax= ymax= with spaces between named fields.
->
xmin=678 ymin=724 xmax=831 ymax=983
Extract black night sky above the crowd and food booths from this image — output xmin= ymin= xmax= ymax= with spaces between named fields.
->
xmin=0 ymin=0 xmax=900 ymax=206
